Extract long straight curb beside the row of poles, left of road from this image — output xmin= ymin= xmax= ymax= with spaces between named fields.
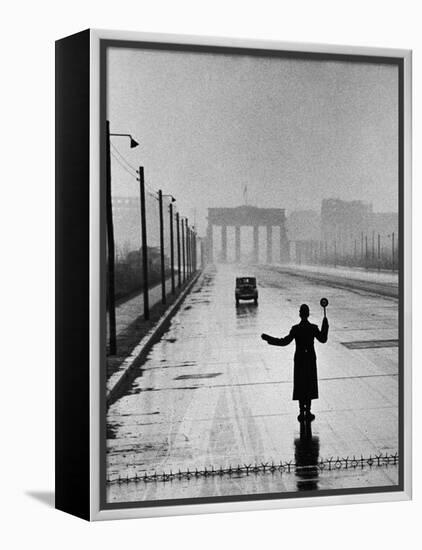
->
xmin=106 ymin=271 xmax=204 ymax=406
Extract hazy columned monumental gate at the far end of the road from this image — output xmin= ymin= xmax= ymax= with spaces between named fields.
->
xmin=207 ymin=205 xmax=289 ymax=263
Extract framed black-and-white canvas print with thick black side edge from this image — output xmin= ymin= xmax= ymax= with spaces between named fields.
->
xmin=56 ymin=30 xmax=411 ymax=520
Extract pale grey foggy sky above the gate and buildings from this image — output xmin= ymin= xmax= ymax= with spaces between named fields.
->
xmin=107 ymin=48 xmax=398 ymax=232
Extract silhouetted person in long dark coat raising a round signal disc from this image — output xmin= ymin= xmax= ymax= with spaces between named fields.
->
xmin=261 ymin=304 xmax=328 ymax=421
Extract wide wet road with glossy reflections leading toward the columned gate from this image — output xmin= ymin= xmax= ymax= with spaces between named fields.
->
xmin=107 ymin=265 xmax=398 ymax=502
